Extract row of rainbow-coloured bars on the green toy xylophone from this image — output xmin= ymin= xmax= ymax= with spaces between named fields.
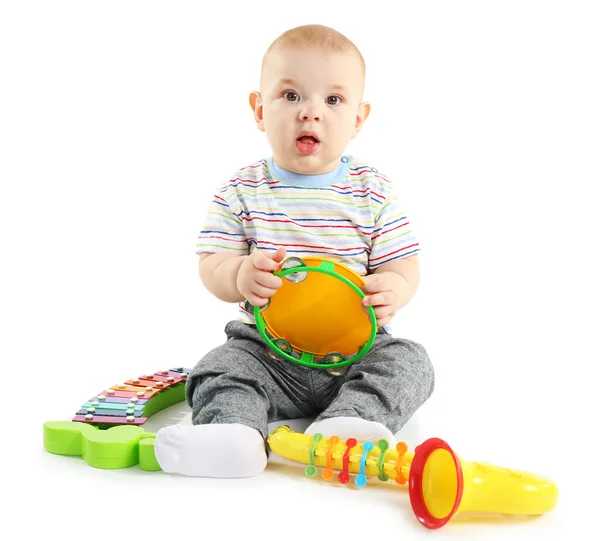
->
xmin=72 ymin=368 xmax=191 ymax=425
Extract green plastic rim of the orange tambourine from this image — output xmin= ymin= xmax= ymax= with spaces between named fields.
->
xmin=254 ymin=261 xmax=377 ymax=370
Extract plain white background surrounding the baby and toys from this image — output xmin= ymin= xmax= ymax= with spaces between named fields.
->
xmin=0 ymin=0 xmax=600 ymax=541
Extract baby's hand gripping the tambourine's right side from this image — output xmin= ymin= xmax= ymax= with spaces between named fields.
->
xmin=362 ymin=272 xmax=411 ymax=327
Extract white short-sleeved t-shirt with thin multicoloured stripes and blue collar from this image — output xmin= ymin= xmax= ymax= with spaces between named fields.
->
xmin=196 ymin=156 xmax=420 ymax=322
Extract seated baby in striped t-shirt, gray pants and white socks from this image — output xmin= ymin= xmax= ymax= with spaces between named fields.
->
xmin=155 ymin=25 xmax=434 ymax=477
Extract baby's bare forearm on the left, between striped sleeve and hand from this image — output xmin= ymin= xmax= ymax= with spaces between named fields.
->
xmin=198 ymin=253 xmax=250 ymax=302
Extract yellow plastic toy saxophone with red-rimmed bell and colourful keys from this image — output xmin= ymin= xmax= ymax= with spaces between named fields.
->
xmin=268 ymin=425 xmax=558 ymax=529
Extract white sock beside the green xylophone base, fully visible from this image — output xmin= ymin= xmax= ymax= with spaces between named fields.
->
xmin=154 ymin=423 xmax=267 ymax=477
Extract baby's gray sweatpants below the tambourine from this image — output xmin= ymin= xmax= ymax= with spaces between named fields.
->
xmin=186 ymin=321 xmax=434 ymax=438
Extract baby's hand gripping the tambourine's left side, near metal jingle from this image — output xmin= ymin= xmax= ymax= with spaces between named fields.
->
xmin=236 ymin=247 xmax=286 ymax=306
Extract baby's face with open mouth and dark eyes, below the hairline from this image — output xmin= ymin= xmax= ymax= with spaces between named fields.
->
xmin=251 ymin=49 xmax=369 ymax=175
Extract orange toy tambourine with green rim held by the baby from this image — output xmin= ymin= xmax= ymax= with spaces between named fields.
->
xmin=249 ymin=257 xmax=377 ymax=375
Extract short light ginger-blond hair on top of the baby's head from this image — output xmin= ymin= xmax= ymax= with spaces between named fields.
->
xmin=262 ymin=24 xmax=365 ymax=76
